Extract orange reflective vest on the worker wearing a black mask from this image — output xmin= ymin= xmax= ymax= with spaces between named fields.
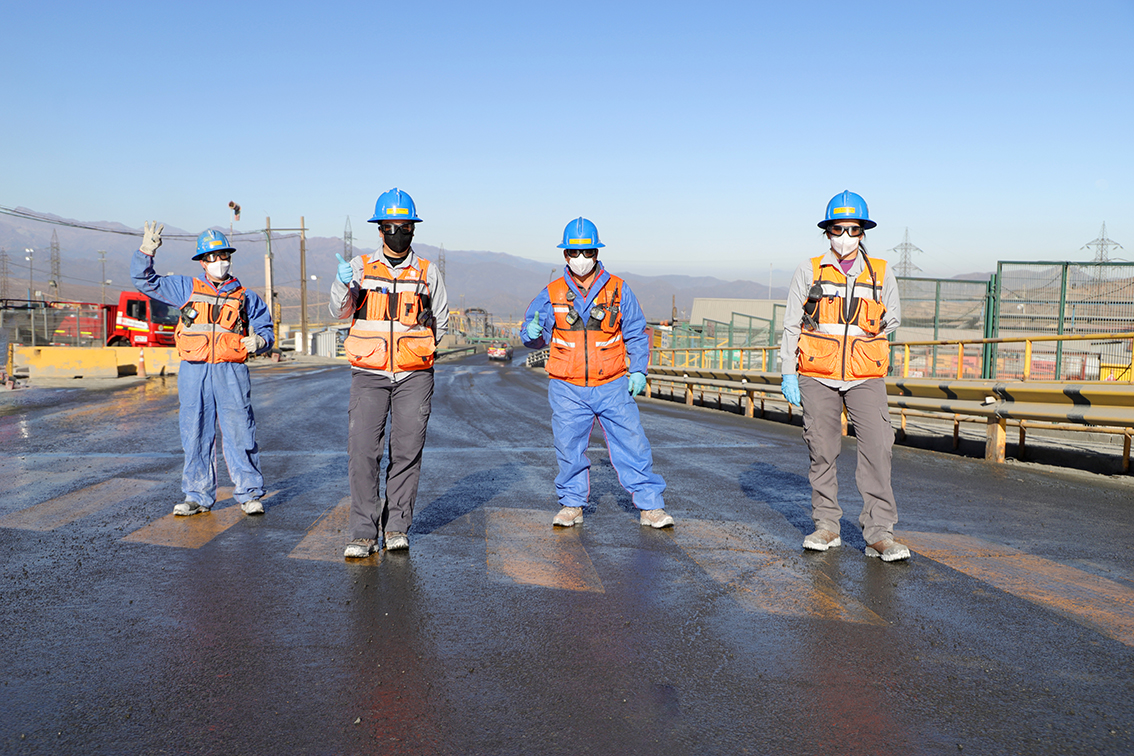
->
xmin=342 ymin=255 xmax=437 ymax=373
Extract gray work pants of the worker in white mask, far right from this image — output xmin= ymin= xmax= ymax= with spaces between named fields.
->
xmin=799 ymin=375 xmax=898 ymax=544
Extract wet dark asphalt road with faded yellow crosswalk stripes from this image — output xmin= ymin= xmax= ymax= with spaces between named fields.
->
xmin=0 ymin=356 xmax=1134 ymax=754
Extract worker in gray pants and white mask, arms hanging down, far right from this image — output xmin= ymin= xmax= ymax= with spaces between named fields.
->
xmin=780 ymin=192 xmax=909 ymax=562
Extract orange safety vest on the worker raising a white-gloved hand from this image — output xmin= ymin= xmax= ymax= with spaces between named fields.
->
xmin=174 ymin=278 xmax=248 ymax=363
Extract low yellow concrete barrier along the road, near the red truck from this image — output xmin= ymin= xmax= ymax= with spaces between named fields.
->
xmin=9 ymin=345 xmax=181 ymax=379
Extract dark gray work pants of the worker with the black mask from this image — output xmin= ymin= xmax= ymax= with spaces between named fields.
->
xmin=347 ymin=369 xmax=433 ymax=541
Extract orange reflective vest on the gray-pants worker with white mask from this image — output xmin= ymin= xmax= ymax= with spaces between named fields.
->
xmin=796 ymin=252 xmax=890 ymax=381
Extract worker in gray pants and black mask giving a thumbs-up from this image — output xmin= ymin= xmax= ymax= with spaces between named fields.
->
xmin=330 ymin=189 xmax=449 ymax=559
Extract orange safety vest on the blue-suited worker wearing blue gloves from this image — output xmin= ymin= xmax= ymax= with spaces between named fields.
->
xmin=547 ymin=275 xmax=626 ymax=385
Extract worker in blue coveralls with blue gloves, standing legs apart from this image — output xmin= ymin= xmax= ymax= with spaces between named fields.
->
xmin=523 ymin=218 xmax=674 ymax=528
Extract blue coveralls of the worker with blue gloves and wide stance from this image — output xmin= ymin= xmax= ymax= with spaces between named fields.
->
xmin=521 ymin=263 xmax=666 ymax=509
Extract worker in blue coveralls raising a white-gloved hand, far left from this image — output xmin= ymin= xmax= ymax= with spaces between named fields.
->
xmin=130 ymin=222 xmax=273 ymax=516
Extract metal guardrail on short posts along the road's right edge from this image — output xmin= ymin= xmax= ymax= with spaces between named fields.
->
xmin=645 ymin=365 xmax=1134 ymax=472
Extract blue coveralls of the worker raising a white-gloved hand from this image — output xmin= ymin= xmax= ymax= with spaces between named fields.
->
xmin=130 ymin=252 xmax=274 ymax=509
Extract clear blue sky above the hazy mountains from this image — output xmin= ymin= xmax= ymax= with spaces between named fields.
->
xmin=0 ymin=0 xmax=1134 ymax=280
